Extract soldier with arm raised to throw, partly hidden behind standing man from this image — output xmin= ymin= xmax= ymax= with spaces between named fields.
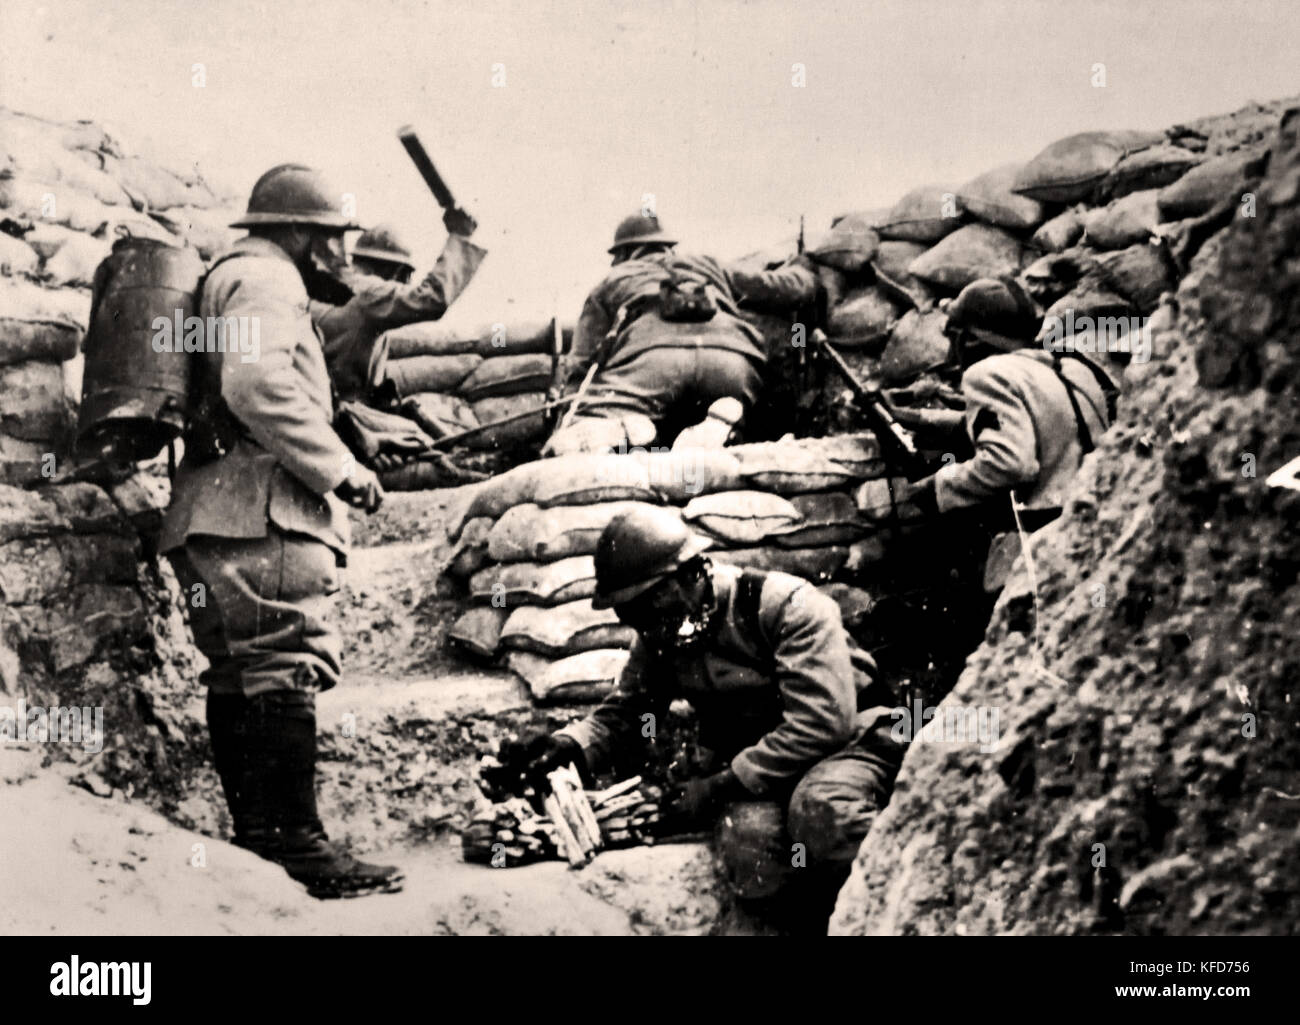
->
xmin=311 ymin=208 xmax=488 ymax=399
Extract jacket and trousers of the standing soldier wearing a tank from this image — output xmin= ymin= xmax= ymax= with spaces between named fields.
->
xmin=160 ymin=237 xmax=354 ymax=697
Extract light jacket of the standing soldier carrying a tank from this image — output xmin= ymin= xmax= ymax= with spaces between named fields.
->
xmin=160 ymin=235 xmax=354 ymax=555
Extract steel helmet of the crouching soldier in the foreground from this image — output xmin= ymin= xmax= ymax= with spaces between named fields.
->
xmin=592 ymin=506 xmax=710 ymax=609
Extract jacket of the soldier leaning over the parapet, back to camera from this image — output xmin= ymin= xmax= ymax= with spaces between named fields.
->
xmin=560 ymin=251 xmax=818 ymax=384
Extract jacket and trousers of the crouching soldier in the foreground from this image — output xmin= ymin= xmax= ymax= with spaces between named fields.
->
xmin=560 ymin=565 xmax=904 ymax=898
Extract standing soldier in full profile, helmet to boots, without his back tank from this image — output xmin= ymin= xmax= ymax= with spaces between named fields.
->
xmin=160 ymin=164 xmax=402 ymax=898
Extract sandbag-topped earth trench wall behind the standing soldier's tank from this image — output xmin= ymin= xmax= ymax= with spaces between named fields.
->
xmin=0 ymin=109 xmax=220 ymax=795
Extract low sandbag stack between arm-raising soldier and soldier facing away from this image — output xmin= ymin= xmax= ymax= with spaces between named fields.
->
xmin=384 ymin=320 xmax=572 ymax=450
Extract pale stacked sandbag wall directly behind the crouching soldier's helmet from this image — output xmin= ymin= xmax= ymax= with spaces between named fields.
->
xmin=445 ymin=434 xmax=884 ymax=702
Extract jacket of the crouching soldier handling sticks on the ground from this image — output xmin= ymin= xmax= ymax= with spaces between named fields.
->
xmin=560 ymin=565 xmax=879 ymax=795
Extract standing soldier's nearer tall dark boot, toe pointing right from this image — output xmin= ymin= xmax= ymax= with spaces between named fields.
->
xmin=237 ymin=691 xmax=404 ymax=900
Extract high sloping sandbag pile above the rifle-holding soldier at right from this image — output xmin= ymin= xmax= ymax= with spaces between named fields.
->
xmin=785 ymin=118 xmax=1265 ymax=408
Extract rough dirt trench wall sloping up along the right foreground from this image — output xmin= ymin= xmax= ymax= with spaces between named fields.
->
xmin=832 ymin=112 xmax=1300 ymax=934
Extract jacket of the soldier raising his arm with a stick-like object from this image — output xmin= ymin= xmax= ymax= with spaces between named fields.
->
xmin=311 ymin=234 xmax=488 ymax=399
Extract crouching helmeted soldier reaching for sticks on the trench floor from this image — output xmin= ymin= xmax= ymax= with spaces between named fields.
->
xmin=488 ymin=506 xmax=904 ymax=933
